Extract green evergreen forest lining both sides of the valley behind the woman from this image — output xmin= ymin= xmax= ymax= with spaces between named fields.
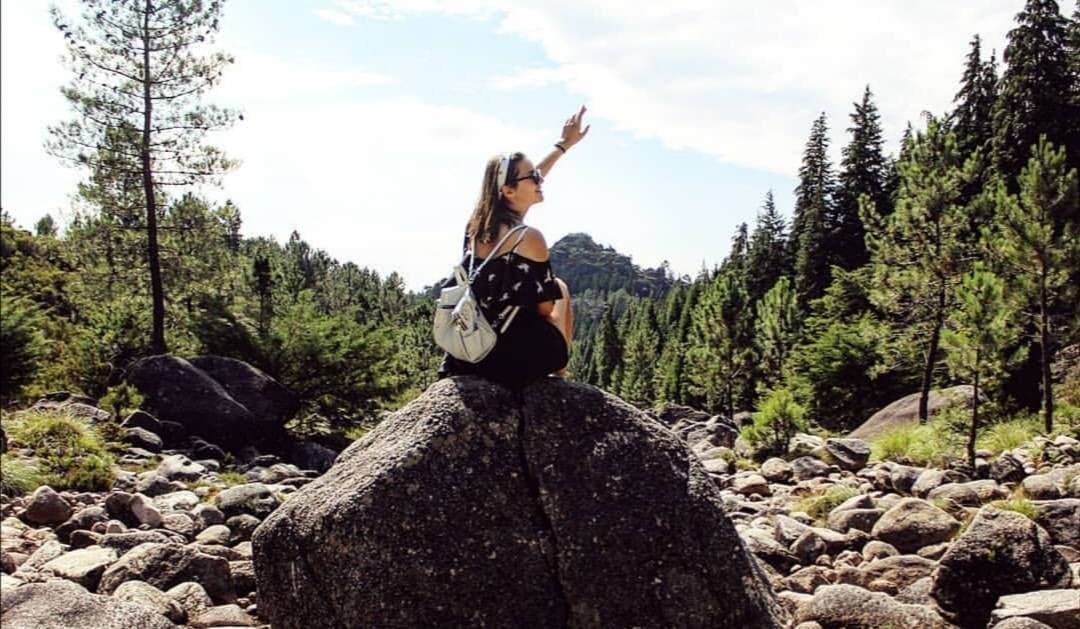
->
xmin=0 ymin=0 xmax=1080 ymax=449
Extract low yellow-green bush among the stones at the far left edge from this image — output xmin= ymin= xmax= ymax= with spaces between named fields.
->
xmin=8 ymin=412 xmax=114 ymax=492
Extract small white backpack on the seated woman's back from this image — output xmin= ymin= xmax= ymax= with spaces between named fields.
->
xmin=433 ymin=225 xmax=528 ymax=363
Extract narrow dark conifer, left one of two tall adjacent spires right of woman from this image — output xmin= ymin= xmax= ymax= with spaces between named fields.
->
xmin=791 ymin=111 xmax=834 ymax=310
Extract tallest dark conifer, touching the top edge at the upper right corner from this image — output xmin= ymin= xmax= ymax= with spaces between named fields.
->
xmin=994 ymin=0 xmax=1080 ymax=185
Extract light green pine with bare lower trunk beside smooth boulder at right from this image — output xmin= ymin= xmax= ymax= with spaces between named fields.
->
xmin=863 ymin=118 xmax=974 ymax=420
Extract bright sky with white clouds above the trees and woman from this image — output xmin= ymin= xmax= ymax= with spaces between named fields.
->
xmin=0 ymin=0 xmax=1023 ymax=290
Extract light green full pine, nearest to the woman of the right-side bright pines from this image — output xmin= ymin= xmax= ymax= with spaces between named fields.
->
xmin=686 ymin=273 xmax=752 ymax=417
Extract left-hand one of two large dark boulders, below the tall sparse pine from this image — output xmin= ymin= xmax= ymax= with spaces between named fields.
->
xmin=127 ymin=354 xmax=259 ymax=453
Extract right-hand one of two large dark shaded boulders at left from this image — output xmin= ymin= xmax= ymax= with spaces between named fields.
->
xmin=190 ymin=356 xmax=300 ymax=430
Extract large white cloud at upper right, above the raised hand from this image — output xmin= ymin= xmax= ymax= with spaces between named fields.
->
xmin=341 ymin=0 xmax=1021 ymax=175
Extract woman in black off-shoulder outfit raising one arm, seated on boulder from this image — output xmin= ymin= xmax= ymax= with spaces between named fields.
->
xmin=438 ymin=107 xmax=589 ymax=389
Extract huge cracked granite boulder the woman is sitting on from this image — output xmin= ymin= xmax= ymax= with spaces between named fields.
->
xmin=253 ymin=377 xmax=782 ymax=628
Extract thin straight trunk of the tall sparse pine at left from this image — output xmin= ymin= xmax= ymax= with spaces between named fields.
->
xmin=139 ymin=0 xmax=166 ymax=353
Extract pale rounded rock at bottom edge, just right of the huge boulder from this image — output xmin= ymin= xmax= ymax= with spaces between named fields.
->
xmin=795 ymin=585 xmax=950 ymax=629
